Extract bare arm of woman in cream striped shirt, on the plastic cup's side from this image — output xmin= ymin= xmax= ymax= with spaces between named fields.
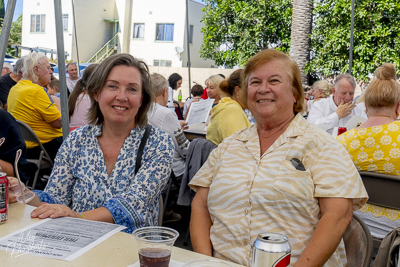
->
xmin=190 ymin=187 xmax=212 ymax=256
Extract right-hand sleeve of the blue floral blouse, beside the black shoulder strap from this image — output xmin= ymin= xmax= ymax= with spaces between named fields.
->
xmin=103 ymin=130 xmax=174 ymax=232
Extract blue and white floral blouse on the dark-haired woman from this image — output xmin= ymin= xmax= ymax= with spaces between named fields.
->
xmin=35 ymin=125 xmax=174 ymax=233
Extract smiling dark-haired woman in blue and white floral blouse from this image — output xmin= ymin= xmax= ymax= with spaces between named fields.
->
xmin=15 ymin=54 xmax=174 ymax=232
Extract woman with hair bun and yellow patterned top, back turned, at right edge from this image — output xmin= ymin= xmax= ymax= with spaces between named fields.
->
xmin=337 ymin=63 xmax=400 ymax=238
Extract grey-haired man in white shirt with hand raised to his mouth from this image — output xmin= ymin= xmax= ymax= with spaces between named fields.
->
xmin=307 ymin=73 xmax=367 ymax=134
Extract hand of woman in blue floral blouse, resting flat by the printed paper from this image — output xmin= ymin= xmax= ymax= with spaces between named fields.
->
xmin=31 ymin=202 xmax=81 ymax=219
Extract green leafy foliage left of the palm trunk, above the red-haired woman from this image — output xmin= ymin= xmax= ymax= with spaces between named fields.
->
xmin=200 ymin=0 xmax=292 ymax=67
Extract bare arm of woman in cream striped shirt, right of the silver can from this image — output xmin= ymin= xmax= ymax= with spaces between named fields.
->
xmin=294 ymin=197 xmax=353 ymax=267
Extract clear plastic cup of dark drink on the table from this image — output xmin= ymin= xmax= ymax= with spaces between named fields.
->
xmin=133 ymin=226 xmax=179 ymax=267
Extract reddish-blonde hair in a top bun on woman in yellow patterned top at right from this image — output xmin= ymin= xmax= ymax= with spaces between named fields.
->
xmin=364 ymin=63 xmax=400 ymax=108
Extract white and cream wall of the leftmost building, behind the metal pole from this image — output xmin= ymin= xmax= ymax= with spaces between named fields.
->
xmin=22 ymin=0 xmax=116 ymax=61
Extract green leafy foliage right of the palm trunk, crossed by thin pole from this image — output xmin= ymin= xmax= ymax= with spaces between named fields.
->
xmin=306 ymin=0 xmax=400 ymax=81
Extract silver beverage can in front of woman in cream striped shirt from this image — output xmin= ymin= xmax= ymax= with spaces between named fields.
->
xmin=251 ymin=233 xmax=291 ymax=267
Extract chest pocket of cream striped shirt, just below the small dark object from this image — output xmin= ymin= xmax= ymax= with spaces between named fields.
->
xmin=274 ymin=158 xmax=315 ymax=202
